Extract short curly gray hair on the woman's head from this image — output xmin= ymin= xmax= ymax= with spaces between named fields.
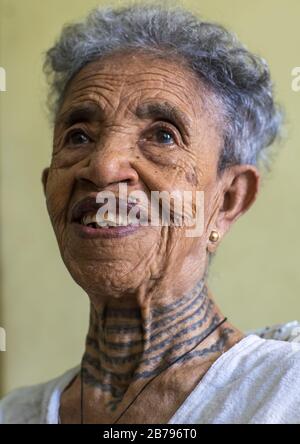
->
xmin=44 ymin=3 xmax=282 ymax=171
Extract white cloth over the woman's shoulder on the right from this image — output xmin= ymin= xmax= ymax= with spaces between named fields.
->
xmin=170 ymin=322 xmax=300 ymax=424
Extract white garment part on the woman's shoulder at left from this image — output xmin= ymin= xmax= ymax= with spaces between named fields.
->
xmin=0 ymin=367 xmax=78 ymax=424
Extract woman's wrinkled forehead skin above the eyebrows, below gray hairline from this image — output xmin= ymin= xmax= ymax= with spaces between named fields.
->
xmin=65 ymin=54 xmax=202 ymax=113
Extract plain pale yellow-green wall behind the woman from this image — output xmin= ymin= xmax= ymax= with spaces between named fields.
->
xmin=0 ymin=0 xmax=300 ymax=394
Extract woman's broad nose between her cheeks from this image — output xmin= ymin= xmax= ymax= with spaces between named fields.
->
xmin=77 ymin=141 xmax=139 ymax=189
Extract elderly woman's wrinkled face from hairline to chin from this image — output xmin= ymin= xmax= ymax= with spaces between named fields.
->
xmin=45 ymin=53 xmax=230 ymax=304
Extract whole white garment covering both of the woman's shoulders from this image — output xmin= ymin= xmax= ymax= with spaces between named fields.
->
xmin=0 ymin=334 xmax=300 ymax=424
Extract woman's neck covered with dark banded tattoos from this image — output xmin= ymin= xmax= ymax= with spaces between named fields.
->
xmin=82 ymin=280 xmax=234 ymax=412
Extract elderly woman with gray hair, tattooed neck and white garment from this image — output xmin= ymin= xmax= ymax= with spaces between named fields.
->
xmin=0 ymin=5 xmax=300 ymax=424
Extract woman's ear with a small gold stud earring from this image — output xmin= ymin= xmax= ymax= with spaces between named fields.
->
xmin=209 ymin=165 xmax=260 ymax=252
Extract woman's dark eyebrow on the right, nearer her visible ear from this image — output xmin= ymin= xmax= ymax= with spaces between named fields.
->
xmin=135 ymin=102 xmax=192 ymax=132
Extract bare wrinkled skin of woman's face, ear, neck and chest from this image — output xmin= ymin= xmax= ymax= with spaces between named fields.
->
xmin=43 ymin=52 xmax=259 ymax=423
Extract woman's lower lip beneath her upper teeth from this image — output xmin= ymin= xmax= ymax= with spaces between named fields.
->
xmin=72 ymin=222 xmax=141 ymax=239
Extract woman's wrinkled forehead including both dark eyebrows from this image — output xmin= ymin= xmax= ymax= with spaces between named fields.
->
xmin=58 ymin=55 xmax=211 ymax=139
